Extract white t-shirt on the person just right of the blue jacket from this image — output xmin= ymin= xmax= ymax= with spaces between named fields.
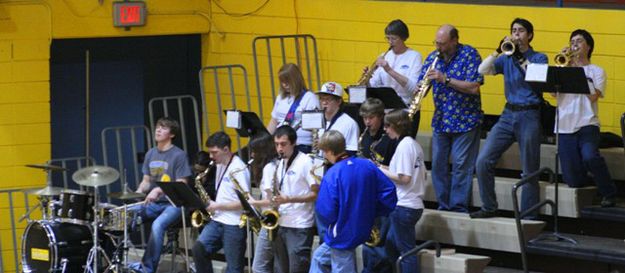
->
xmin=389 ymin=136 xmax=425 ymax=209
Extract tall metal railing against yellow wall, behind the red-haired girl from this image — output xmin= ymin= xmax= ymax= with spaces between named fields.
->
xmin=252 ymin=34 xmax=321 ymax=120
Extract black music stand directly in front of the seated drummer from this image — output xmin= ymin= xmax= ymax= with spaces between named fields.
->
xmin=156 ymin=182 xmax=204 ymax=272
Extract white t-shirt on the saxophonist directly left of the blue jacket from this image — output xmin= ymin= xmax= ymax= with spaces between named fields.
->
xmin=261 ymin=153 xmax=315 ymax=228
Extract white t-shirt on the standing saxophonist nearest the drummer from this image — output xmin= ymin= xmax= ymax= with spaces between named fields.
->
xmin=213 ymin=155 xmax=250 ymax=225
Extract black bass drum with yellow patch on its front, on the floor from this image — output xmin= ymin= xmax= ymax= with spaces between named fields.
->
xmin=22 ymin=220 xmax=93 ymax=273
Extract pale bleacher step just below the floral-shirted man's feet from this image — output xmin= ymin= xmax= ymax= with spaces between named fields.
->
xmin=415 ymin=209 xmax=545 ymax=253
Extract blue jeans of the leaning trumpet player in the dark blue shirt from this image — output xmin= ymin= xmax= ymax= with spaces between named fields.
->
xmin=476 ymin=108 xmax=542 ymax=218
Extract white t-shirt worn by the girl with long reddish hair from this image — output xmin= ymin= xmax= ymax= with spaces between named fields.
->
xmin=271 ymin=91 xmax=319 ymax=145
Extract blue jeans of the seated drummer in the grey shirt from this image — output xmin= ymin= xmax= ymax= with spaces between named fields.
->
xmin=139 ymin=202 xmax=182 ymax=273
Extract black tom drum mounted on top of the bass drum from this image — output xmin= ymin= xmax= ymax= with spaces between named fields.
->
xmin=60 ymin=190 xmax=94 ymax=225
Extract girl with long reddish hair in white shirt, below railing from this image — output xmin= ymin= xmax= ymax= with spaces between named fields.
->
xmin=267 ymin=63 xmax=319 ymax=153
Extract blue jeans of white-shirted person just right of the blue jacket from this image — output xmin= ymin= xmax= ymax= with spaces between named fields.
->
xmin=385 ymin=206 xmax=423 ymax=273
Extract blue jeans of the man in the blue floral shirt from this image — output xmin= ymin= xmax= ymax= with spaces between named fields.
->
xmin=432 ymin=128 xmax=480 ymax=212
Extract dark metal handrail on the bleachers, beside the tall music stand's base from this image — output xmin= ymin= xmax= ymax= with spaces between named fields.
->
xmin=512 ymin=167 xmax=558 ymax=273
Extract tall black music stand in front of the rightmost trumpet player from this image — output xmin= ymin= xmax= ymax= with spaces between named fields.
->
xmin=528 ymin=66 xmax=590 ymax=244
